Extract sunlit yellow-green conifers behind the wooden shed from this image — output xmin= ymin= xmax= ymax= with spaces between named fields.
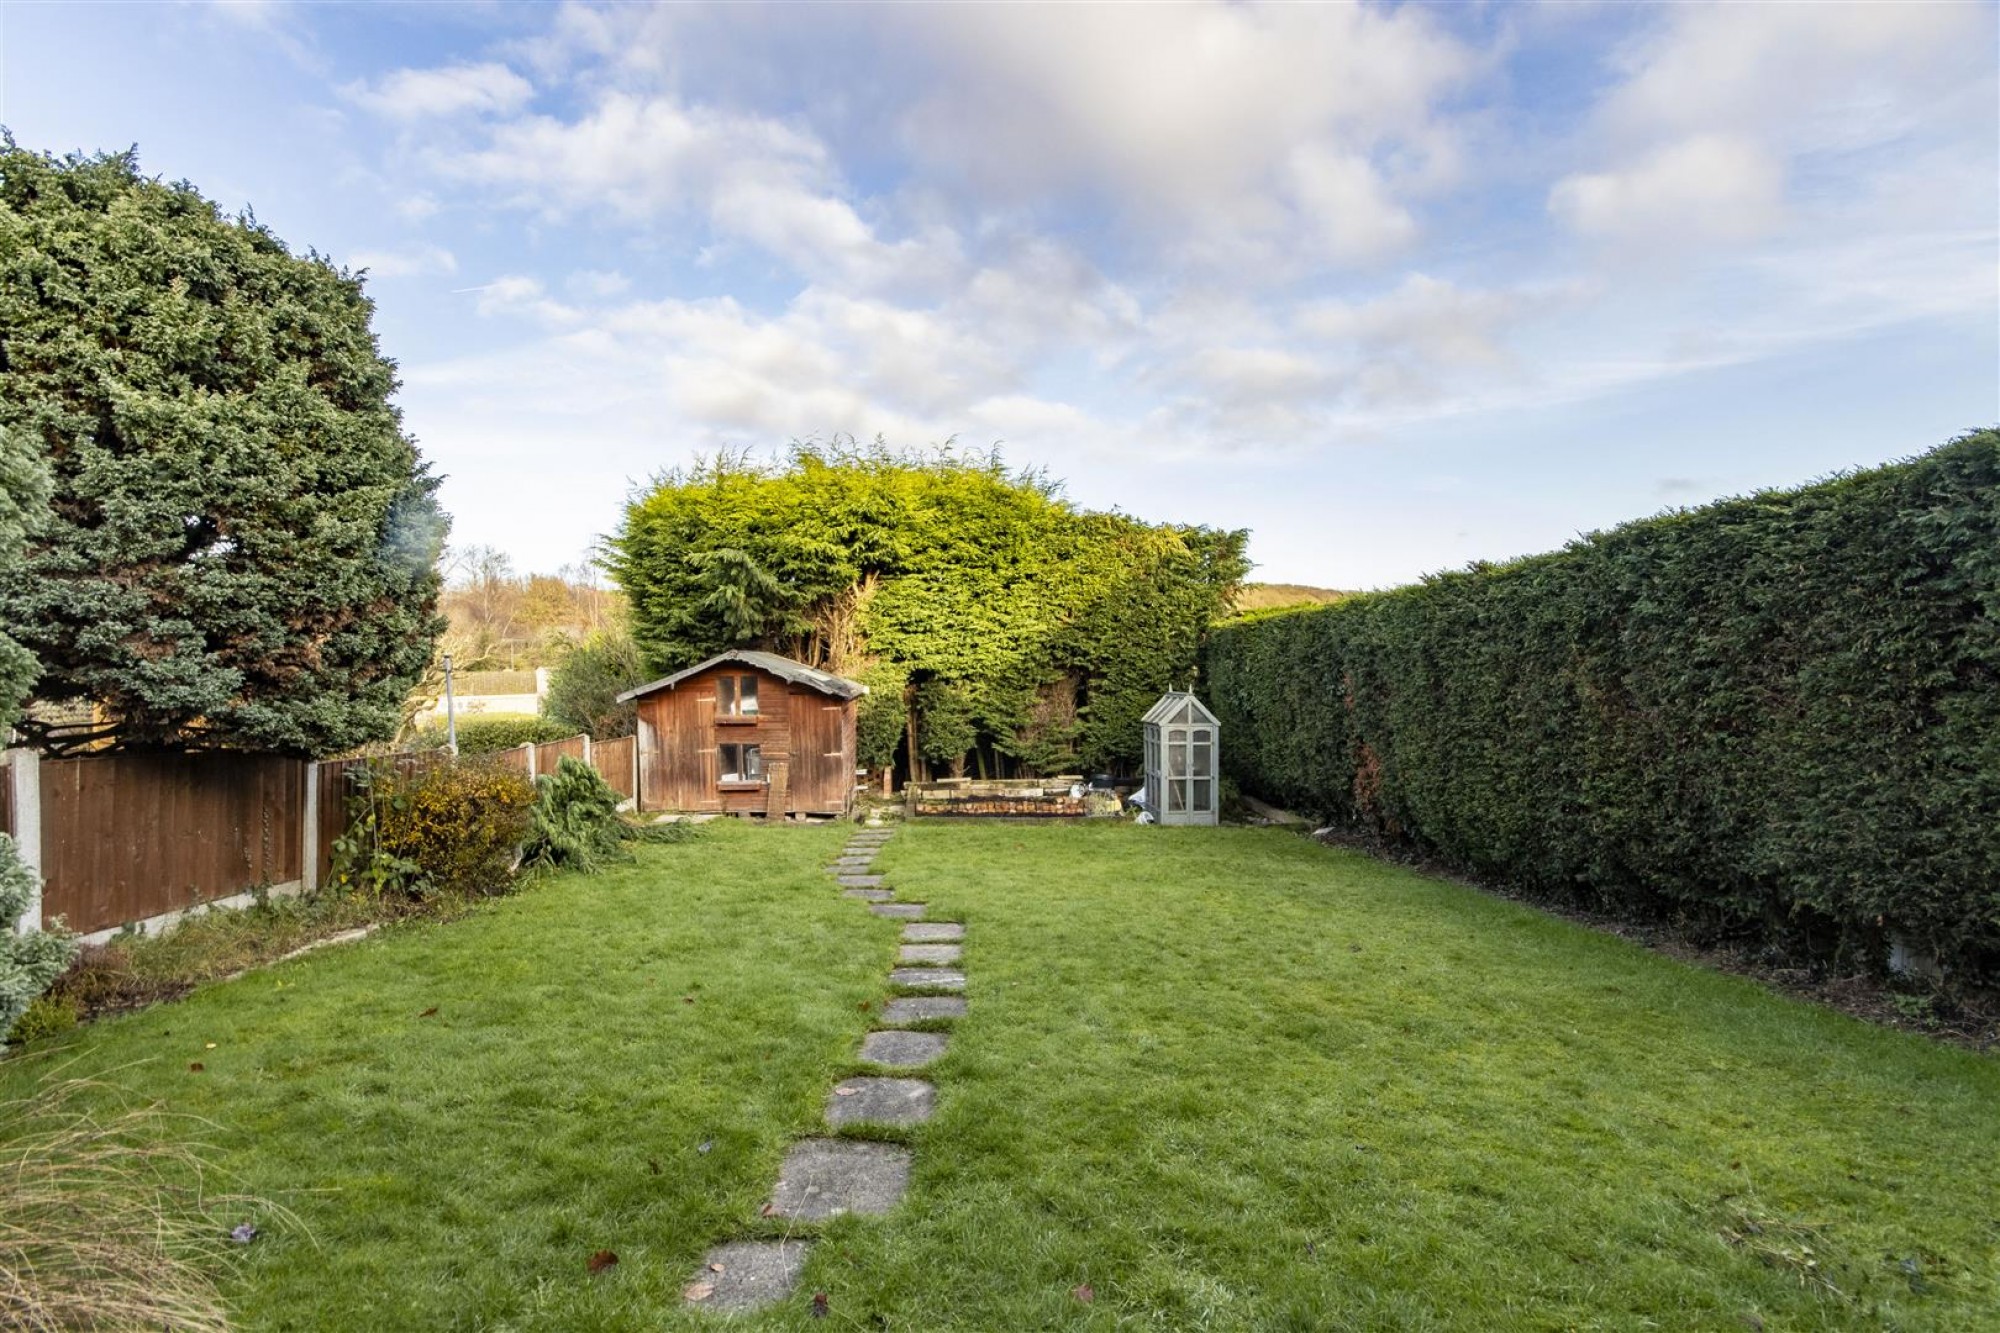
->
xmin=612 ymin=444 xmax=1248 ymax=771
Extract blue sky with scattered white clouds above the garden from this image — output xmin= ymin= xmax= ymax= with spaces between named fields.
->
xmin=0 ymin=0 xmax=2000 ymax=586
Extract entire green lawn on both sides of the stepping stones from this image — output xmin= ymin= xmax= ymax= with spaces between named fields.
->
xmin=0 ymin=825 xmax=2000 ymax=1331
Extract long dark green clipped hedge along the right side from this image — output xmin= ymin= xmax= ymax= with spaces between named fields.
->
xmin=1206 ymin=430 xmax=2000 ymax=975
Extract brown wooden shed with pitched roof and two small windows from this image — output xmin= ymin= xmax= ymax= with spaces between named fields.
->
xmin=618 ymin=648 xmax=868 ymax=815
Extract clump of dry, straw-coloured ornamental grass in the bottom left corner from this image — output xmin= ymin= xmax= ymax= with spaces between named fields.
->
xmin=0 ymin=1079 xmax=256 ymax=1333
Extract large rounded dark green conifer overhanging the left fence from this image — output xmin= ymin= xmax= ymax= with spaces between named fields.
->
xmin=0 ymin=138 xmax=444 ymax=755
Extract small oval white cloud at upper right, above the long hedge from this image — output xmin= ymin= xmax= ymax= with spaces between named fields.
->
xmin=1548 ymin=134 xmax=1784 ymax=246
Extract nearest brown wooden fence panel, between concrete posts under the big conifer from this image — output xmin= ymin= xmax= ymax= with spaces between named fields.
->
xmin=40 ymin=753 xmax=306 ymax=931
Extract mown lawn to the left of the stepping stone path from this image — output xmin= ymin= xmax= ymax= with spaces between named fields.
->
xmin=0 ymin=827 xmax=894 ymax=1329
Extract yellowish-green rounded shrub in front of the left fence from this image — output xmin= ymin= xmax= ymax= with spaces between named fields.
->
xmin=334 ymin=759 xmax=534 ymax=899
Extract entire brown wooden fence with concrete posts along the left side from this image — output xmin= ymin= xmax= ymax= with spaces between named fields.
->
xmin=0 ymin=737 xmax=600 ymax=935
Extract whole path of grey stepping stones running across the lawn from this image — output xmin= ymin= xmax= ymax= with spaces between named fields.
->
xmin=682 ymin=829 xmax=966 ymax=1311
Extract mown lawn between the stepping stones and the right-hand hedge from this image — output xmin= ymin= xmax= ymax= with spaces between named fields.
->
xmin=808 ymin=825 xmax=2000 ymax=1331
